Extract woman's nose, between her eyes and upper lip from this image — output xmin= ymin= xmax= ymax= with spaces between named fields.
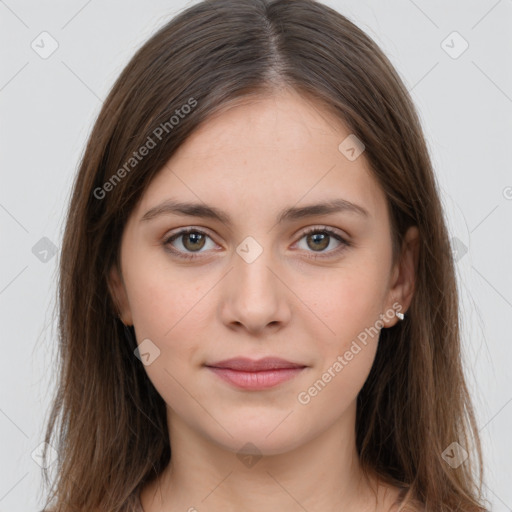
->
xmin=220 ymin=242 xmax=293 ymax=335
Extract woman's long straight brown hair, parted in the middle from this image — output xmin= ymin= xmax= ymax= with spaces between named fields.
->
xmin=43 ymin=0 xmax=485 ymax=512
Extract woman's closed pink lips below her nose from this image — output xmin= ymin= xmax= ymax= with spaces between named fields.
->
xmin=205 ymin=357 xmax=306 ymax=391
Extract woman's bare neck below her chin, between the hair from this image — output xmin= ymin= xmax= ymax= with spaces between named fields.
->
xmin=141 ymin=404 xmax=400 ymax=512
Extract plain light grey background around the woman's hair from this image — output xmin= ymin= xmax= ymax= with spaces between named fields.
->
xmin=0 ymin=0 xmax=512 ymax=512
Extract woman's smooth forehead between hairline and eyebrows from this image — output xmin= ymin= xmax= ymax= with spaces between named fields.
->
xmin=132 ymin=90 xmax=386 ymax=222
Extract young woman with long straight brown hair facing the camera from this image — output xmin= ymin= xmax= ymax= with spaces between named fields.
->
xmin=42 ymin=0 xmax=484 ymax=512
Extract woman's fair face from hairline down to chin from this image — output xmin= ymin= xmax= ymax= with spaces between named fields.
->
xmin=111 ymin=87 xmax=414 ymax=454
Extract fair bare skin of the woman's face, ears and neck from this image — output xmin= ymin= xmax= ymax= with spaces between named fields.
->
xmin=110 ymin=89 xmax=418 ymax=512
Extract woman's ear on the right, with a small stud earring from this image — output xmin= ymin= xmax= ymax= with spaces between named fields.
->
xmin=383 ymin=226 xmax=420 ymax=327
